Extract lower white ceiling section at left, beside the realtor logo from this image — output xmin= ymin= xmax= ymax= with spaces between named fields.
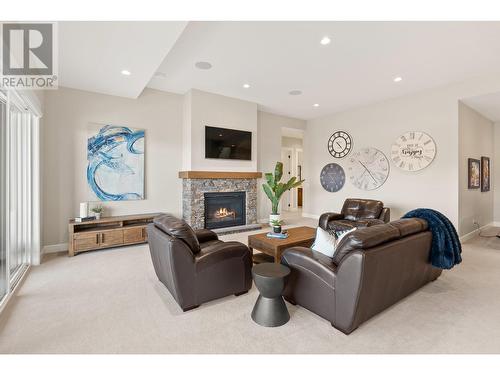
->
xmin=58 ymin=22 xmax=187 ymax=98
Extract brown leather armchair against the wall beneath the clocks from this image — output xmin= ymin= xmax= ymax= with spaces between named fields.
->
xmin=319 ymin=198 xmax=391 ymax=230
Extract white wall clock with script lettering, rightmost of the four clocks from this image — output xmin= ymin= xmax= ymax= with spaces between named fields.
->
xmin=391 ymin=132 xmax=436 ymax=172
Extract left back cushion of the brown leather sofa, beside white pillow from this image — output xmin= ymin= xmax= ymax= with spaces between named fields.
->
xmin=333 ymin=224 xmax=400 ymax=265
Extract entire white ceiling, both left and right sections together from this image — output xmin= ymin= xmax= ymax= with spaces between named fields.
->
xmin=59 ymin=21 xmax=500 ymax=119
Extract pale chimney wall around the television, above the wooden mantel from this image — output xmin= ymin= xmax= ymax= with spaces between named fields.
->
xmin=182 ymin=90 xmax=258 ymax=172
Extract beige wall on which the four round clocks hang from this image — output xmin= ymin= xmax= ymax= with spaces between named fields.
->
xmin=304 ymin=76 xmax=500 ymax=228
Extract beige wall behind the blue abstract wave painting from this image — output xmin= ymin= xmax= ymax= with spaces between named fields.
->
xmin=42 ymin=88 xmax=182 ymax=245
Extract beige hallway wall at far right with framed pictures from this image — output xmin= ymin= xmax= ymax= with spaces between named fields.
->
xmin=458 ymin=102 xmax=495 ymax=235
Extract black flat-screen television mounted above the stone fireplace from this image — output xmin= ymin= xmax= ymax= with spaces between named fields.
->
xmin=205 ymin=126 xmax=252 ymax=160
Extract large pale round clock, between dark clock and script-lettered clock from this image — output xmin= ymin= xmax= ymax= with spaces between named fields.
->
xmin=348 ymin=147 xmax=389 ymax=190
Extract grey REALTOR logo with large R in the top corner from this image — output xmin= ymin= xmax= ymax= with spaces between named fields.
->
xmin=0 ymin=23 xmax=57 ymax=89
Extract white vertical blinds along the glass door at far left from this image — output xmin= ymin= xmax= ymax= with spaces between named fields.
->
xmin=0 ymin=92 xmax=40 ymax=310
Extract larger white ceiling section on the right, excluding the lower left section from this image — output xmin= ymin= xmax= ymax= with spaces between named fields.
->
xmin=148 ymin=22 xmax=500 ymax=119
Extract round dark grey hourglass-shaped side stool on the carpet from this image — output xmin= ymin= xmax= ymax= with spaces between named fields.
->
xmin=252 ymin=263 xmax=290 ymax=327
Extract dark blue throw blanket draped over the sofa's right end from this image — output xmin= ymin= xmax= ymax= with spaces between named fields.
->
xmin=403 ymin=208 xmax=462 ymax=270
